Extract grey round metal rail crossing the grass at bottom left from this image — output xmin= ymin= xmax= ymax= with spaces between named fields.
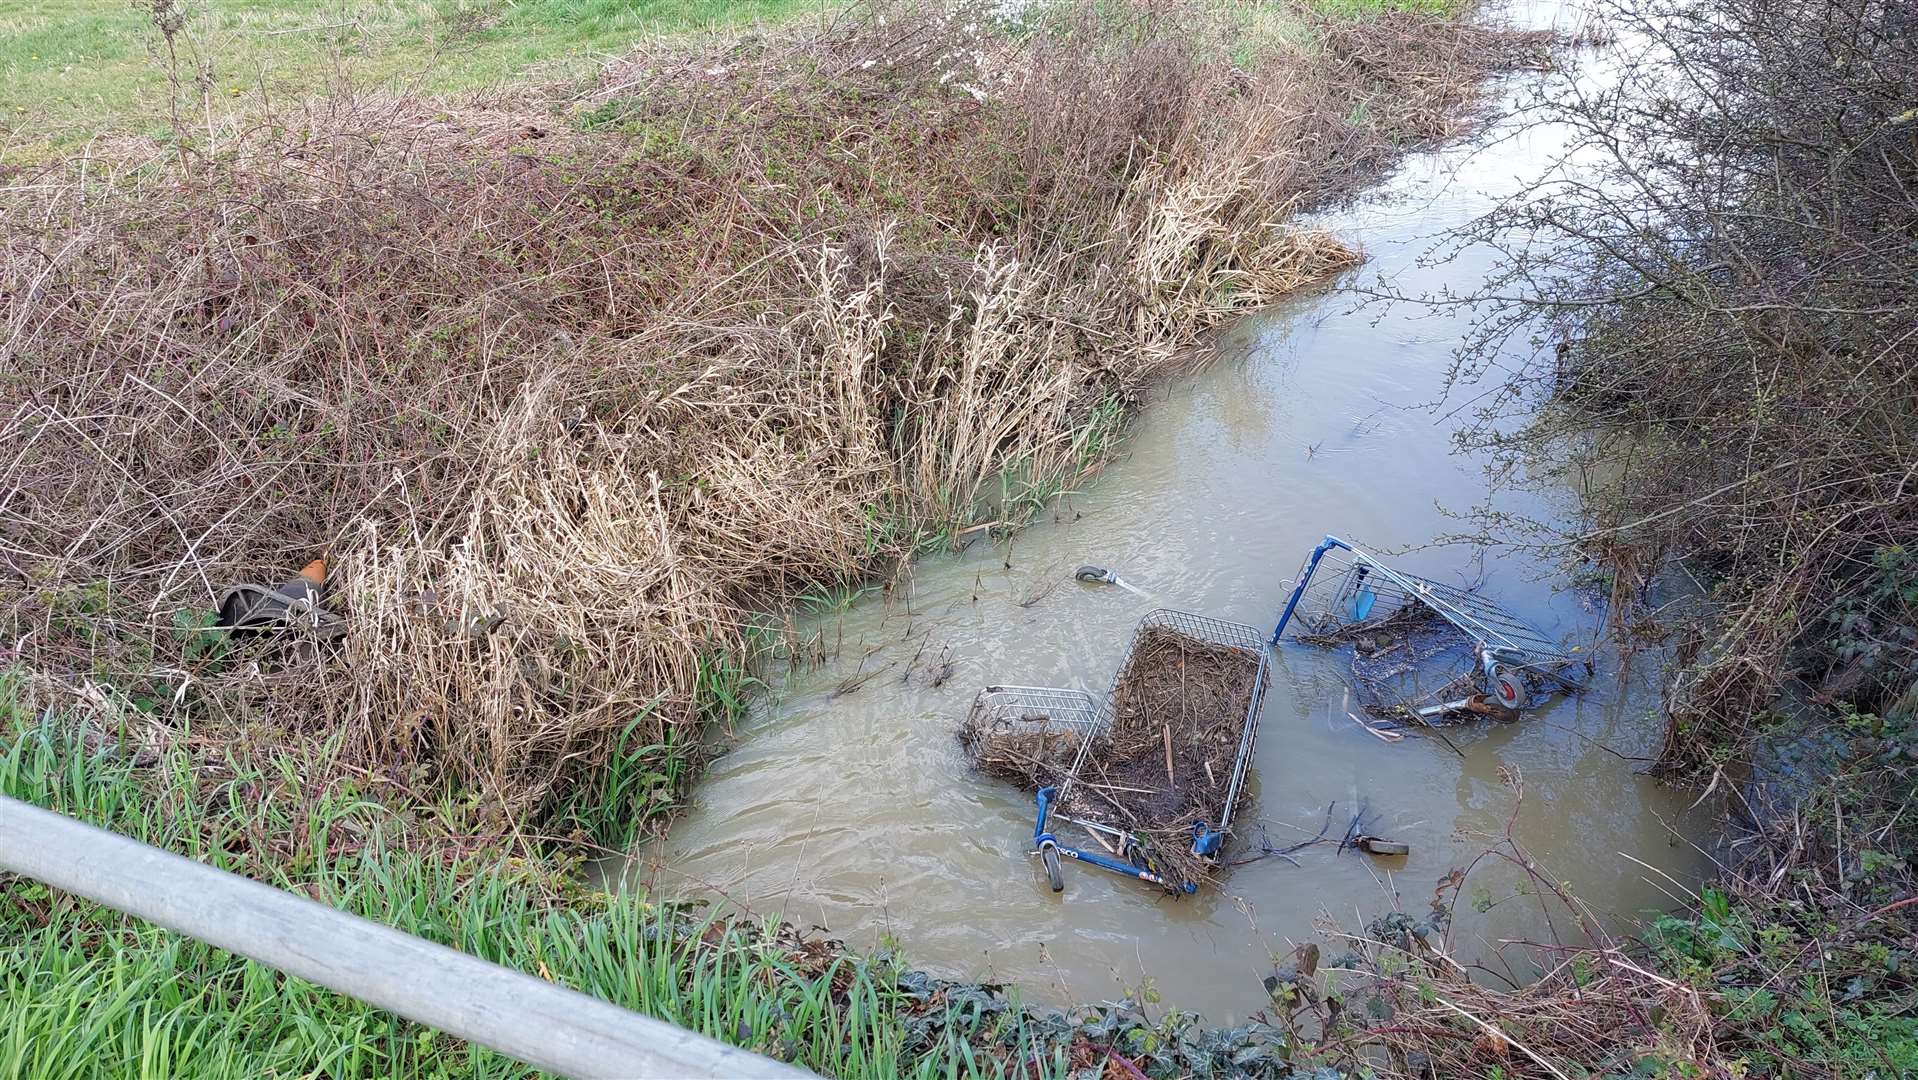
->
xmin=0 ymin=796 xmax=811 ymax=1078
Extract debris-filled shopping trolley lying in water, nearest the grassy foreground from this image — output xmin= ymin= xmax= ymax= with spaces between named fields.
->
xmin=965 ymin=610 xmax=1270 ymax=892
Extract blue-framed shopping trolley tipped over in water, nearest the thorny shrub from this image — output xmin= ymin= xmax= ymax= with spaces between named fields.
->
xmin=1272 ymin=535 xmax=1592 ymax=723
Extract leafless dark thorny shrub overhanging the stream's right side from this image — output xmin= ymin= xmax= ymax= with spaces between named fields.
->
xmin=1458 ymin=0 xmax=1918 ymax=773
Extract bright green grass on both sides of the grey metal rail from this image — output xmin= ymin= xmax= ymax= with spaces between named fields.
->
xmin=0 ymin=708 xmax=1055 ymax=1080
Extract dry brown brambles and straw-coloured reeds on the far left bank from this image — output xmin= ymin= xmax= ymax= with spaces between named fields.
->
xmin=0 ymin=4 xmax=1508 ymax=840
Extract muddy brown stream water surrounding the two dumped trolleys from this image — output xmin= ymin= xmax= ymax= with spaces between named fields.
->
xmin=627 ymin=10 xmax=1705 ymax=1022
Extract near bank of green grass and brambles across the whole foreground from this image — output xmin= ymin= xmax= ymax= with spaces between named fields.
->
xmin=11 ymin=708 xmax=1918 ymax=1080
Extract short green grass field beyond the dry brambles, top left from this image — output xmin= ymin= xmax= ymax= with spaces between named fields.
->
xmin=0 ymin=0 xmax=829 ymax=157
